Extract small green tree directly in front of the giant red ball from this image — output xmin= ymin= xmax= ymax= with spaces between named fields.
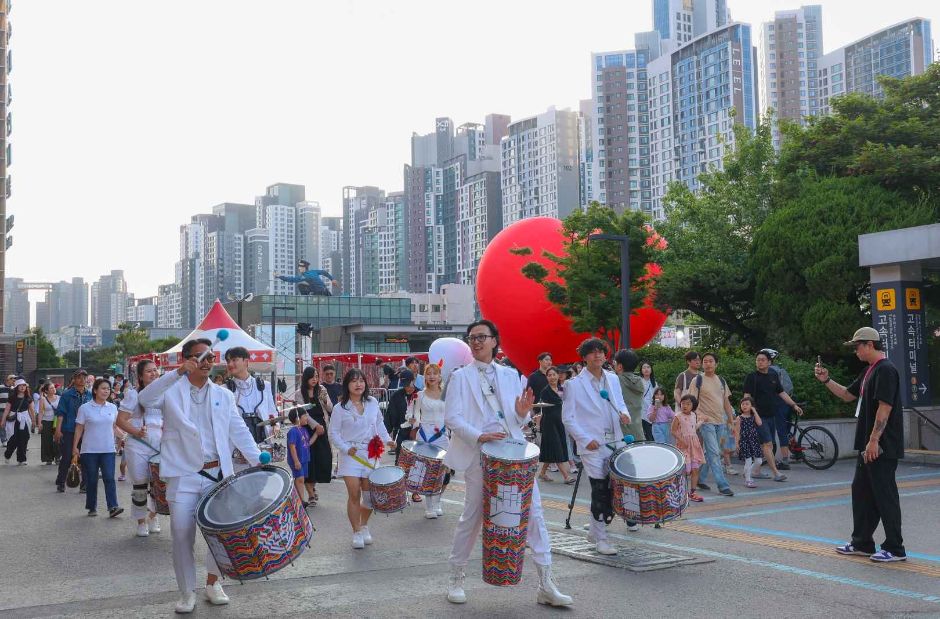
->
xmin=515 ymin=202 xmax=652 ymax=347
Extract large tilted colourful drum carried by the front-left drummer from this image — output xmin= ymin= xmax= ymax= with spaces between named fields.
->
xmin=196 ymin=465 xmax=313 ymax=581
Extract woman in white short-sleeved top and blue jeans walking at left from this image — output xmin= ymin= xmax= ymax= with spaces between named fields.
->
xmin=72 ymin=378 xmax=124 ymax=518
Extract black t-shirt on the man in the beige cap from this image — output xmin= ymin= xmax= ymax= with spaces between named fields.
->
xmin=846 ymin=359 xmax=904 ymax=458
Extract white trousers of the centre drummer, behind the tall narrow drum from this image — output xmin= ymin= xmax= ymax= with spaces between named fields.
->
xmin=450 ymin=464 xmax=552 ymax=567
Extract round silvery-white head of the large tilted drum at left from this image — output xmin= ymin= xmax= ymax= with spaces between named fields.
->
xmin=198 ymin=466 xmax=291 ymax=529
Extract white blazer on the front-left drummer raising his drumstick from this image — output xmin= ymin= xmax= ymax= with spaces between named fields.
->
xmin=137 ymin=370 xmax=261 ymax=477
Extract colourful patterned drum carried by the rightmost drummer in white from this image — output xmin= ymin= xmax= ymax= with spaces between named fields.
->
xmin=610 ymin=442 xmax=689 ymax=524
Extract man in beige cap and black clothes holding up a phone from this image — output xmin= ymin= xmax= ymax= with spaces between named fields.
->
xmin=815 ymin=327 xmax=907 ymax=563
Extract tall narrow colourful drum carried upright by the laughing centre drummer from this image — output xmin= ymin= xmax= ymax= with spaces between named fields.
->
xmin=480 ymin=439 xmax=539 ymax=587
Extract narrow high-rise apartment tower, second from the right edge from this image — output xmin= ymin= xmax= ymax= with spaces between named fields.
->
xmin=759 ymin=5 xmax=823 ymax=148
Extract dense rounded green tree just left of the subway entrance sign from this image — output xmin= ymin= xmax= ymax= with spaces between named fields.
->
xmin=752 ymin=177 xmax=940 ymax=359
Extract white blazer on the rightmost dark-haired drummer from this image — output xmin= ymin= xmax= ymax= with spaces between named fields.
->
xmin=561 ymin=369 xmax=627 ymax=455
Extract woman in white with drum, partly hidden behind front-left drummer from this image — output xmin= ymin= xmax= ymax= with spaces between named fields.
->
xmin=117 ymin=359 xmax=163 ymax=537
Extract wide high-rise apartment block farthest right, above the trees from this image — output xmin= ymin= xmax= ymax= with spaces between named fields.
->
xmin=818 ymin=17 xmax=934 ymax=114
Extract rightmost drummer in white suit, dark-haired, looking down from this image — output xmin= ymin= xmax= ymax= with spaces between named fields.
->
xmin=561 ymin=337 xmax=630 ymax=555
